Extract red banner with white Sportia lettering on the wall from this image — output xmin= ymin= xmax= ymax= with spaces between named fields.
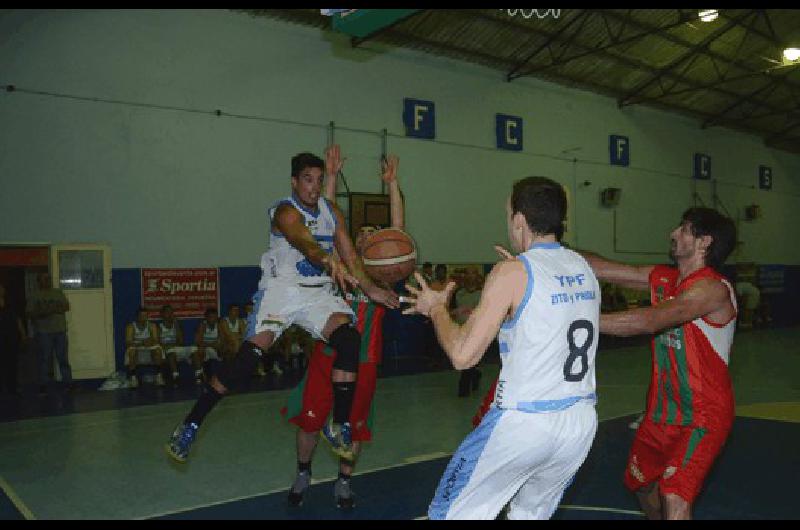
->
xmin=142 ymin=269 xmax=219 ymax=318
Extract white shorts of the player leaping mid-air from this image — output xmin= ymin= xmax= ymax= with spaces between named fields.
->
xmin=245 ymin=280 xmax=355 ymax=340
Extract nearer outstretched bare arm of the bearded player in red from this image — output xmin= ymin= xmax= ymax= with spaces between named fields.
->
xmin=600 ymin=280 xmax=735 ymax=337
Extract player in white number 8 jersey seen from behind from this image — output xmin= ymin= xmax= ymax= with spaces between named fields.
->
xmin=404 ymin=177 xmax=600 ymax=519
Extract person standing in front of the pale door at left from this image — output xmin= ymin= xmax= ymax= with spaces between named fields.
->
xmin=26 ymin=272 xmax=74 ymax=394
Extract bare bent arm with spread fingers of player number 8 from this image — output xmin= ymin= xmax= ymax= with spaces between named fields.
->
xmin=404 ymin=260 xmax=527 ymax=370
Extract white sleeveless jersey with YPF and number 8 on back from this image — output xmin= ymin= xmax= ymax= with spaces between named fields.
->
xmin=494 ymin=243 xmax=600 ymax=412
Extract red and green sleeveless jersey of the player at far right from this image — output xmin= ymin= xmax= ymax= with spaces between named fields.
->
xmin=647 ymin=265 xmax=736 ymax=427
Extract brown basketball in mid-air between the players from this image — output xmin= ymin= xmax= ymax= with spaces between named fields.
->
xmin=362 ymin=228 xmax=417 ymax=285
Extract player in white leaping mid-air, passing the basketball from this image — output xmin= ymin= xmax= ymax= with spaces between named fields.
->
xmin=166 ymin=146 xmax=398 ymax=462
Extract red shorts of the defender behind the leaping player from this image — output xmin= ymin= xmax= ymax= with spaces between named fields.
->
xmin=281 ymin=343 xmax=378 ymax=442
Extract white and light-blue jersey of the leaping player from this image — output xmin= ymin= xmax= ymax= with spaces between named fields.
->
xmin=259 ymin=197 xmax=336 ymax=289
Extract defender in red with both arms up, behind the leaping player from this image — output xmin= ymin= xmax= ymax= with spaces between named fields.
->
xmin=281 ymin=151 xmax=404 ymax=508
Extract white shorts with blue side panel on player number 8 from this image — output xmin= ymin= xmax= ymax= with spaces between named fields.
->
xmin=428 ymin=401 xmax=597 ymax=520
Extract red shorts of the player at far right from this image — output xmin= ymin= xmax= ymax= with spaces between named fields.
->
xmin=624 ymin=417 xmax=731 ymax=503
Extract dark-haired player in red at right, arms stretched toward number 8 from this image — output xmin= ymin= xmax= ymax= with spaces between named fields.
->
xmin=582 ymin=208 xmax=737 ymax=519
